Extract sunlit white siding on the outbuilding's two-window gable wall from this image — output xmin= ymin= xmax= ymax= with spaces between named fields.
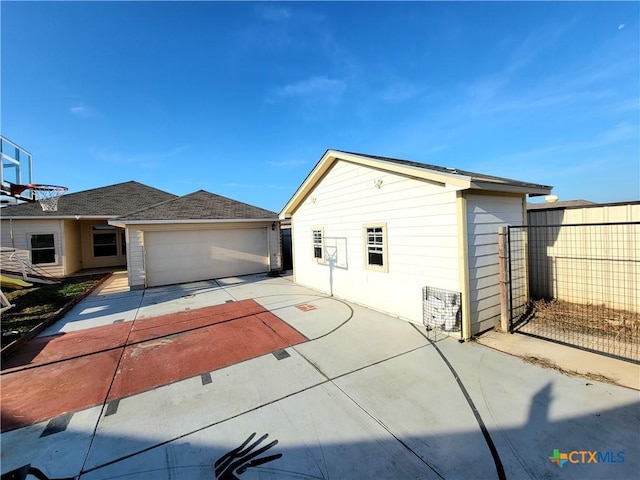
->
xmin=292 ymin=160 xmax=459 ymax=322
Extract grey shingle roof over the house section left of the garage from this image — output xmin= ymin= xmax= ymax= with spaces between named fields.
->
xmin=0 ymin=181 xmax=176 ymax=218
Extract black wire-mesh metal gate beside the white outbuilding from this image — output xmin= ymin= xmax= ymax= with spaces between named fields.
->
xmin=505 ymin=222 xmax=640 ymax=363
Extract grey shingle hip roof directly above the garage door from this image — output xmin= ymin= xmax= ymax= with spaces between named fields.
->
xmin=118 ymin=190 xmax=278 ymax=222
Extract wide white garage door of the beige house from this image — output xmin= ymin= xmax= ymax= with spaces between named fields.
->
xmin=144 ymin=228 xmax=269 ymax=287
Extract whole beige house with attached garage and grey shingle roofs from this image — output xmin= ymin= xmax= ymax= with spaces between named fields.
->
xmin=0 ymin=182 xmax=281 ymax=288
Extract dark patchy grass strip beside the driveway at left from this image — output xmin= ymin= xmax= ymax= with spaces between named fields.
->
xmin=2 ymin=275 xmax=105 ymax=346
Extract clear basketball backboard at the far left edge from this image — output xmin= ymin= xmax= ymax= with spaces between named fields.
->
xmin=0 ymin=136 xmax=34 ymax=203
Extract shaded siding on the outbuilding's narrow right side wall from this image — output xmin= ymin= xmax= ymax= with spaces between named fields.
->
xmin=465 ymin=194 xmax=523 ymax=335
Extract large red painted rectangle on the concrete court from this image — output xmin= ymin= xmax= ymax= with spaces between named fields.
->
xmin=1 ymin=300 xmax=306 ymax=431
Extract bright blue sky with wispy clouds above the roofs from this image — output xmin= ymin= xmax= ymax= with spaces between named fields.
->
xmin=0 ymin=1 xmax=640 ymax=211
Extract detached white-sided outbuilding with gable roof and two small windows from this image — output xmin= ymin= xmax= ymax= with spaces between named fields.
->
xmin=280 ymin=150 xmax=551 ymax=339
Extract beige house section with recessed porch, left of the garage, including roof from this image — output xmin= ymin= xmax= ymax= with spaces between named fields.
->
xmin=0 ymin=181 xmax=176 ymax=277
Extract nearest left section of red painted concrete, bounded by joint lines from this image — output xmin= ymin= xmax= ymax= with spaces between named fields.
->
xmin=2 ymin=347 xmax=122 ymax=432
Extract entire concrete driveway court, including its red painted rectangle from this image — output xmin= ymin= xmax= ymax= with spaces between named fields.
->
xmin=0 ymin=276 xmax=640 ymax=479
